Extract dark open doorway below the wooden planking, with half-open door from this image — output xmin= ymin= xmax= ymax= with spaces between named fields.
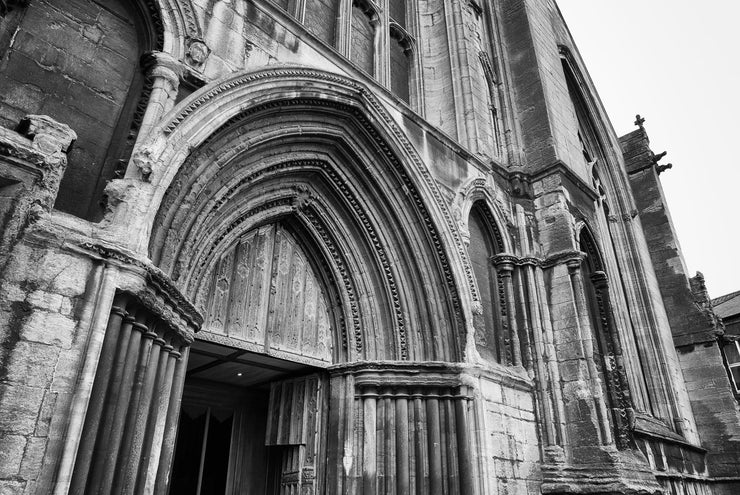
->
xmin=169 ymin=341 xmax=320 ymax=495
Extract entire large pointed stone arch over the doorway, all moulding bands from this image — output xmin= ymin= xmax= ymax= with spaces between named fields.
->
xmin=127 ymin=68 xmax=471 ymax=360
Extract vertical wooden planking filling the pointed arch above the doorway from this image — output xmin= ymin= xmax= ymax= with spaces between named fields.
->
xmin=203 ymin=224 xmax=332 ymax=363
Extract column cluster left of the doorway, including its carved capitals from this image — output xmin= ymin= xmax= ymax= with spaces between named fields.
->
xmin=66 ymin=266 xmax=202 ymax=495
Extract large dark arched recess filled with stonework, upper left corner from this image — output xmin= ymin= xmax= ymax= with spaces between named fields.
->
xmin=0 ymin=0 xmax=161 ymax=219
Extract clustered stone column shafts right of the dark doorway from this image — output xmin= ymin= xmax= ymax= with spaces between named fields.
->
xmin=356 ymin=385 xmax=473 ymax=495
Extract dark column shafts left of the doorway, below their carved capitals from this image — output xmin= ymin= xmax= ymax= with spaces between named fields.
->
xmin=70 ymin=293 xmax=186 ymax=494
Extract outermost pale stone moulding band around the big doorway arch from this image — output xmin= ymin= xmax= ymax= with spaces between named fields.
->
xmin=104 ymin=67 xmax=482 ymax=360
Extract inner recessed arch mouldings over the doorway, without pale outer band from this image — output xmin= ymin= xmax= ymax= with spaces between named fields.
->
xmin=149 ymin=76 xmax=463 ymax=360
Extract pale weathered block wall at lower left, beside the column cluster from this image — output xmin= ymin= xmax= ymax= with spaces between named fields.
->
xmin=0 ymin=239 xmax=100 ymax=493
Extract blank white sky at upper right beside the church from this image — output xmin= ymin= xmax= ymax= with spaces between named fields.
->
xmin=557 ymin=0 xmax=740 ymax=298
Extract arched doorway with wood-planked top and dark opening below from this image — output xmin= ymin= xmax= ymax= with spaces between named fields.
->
xmin=170 ymin=222 xmax=332 ymax=495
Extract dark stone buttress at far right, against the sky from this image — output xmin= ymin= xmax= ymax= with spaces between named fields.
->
xmin=620 ymin=126 xmax=740 ymax=493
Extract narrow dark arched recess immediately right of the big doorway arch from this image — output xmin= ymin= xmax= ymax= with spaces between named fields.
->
xmin=468 ymin=203 xmax=505 ymax=362
